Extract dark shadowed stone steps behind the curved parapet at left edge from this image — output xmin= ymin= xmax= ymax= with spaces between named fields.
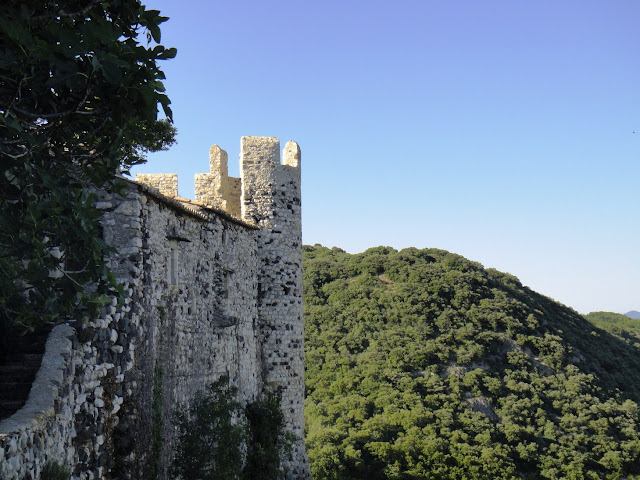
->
xmin=0 ymin=327 xmax=51 ymax=420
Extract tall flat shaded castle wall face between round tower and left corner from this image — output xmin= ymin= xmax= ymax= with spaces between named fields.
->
xmin=129 ymin=186 xmax=262 ymax=478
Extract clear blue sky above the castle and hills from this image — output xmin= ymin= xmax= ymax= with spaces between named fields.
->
xmin=134 ymin=0 xmax=640 ymax=313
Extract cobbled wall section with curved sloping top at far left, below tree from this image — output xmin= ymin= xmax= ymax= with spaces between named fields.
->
xmin=0 ymin=185 xmax=140 ymax=480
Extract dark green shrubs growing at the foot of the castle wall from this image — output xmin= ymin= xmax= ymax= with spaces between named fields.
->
xmin=172 ymin=376 xmax=292 ymax=480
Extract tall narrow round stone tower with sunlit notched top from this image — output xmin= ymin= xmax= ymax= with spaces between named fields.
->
xmin=240 ymin=137 xmax=310 ymax=478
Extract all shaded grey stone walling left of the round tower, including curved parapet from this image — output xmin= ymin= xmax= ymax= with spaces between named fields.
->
xmin=0 ymin=181 xmax=263 ymax=480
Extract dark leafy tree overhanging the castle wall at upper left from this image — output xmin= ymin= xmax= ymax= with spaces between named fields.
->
xmin=0 ymin=0 xmax=176 ymax=337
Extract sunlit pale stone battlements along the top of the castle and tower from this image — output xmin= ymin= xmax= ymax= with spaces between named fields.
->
xmin=136 ymin=137 xmax=301 ymax=223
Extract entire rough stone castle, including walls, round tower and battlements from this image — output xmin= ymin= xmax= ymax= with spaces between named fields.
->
xmin=0 ymin=137 xmax=310 ymax=480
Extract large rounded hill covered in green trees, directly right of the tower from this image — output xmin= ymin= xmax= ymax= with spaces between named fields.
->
xmin=304 ymin=246 xmax=640 ymax=480
